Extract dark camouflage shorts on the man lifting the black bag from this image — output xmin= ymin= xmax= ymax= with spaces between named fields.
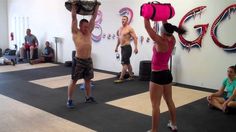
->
xmin=71 ymin=58 xmax=94 ymax=80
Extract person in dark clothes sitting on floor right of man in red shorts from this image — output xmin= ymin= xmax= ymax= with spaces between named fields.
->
xmin=29 ymin=41 xmax=54 ymax=65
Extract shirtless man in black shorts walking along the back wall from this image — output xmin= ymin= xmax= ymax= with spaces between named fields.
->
xmin=114 ymin=16 xmax=138 ymax=83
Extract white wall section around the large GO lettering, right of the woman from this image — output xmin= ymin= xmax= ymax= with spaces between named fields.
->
xmin=173 ymin=0 xmax=236 ymax=89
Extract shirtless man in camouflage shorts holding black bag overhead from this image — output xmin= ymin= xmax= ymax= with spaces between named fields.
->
xmin=67 ymin=4 xmax=100 ymax=108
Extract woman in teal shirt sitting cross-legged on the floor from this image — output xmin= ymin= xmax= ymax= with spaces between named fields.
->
xmin=207 ymin=65 xmax=236 ymax=113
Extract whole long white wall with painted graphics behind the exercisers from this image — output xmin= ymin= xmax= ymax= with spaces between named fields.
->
xmin=8 ymin=0 xmax=236 ymax=89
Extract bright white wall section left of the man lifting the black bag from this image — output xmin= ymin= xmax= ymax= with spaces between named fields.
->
xmin=8 ymin=0 xmax=71 ymax=62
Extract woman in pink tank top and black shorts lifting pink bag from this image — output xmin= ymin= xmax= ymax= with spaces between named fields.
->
xmin=144 ymin=18 xmax=186 ymax=132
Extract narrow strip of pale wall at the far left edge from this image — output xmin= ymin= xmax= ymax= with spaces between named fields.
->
xmin=0 ymin=0 xmax=9 ymax=50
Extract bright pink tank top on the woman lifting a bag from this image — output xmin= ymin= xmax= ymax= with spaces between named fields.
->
xmin=152 ymin=39 xmax=175 ymax=71
